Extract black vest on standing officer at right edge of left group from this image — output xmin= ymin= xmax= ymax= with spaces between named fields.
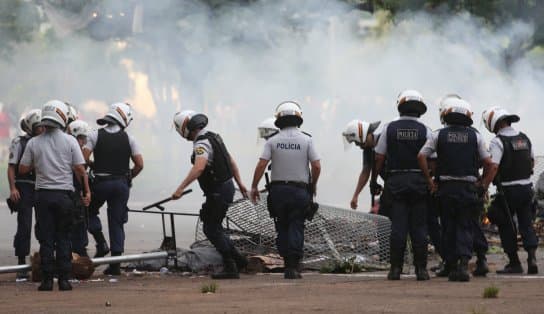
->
xmin=93 ymin=129 xmax=132 ymax=176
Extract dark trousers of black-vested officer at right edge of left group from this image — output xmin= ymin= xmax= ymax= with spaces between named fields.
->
xmin=89 ymin=178 xmax=130 ymax=254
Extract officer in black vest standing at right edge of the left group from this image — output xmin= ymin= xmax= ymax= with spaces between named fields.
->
xmin=83 ymin=103 xmax=144 ymax=276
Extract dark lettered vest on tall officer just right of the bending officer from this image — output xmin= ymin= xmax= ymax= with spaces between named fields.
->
xmin=386 ymin=120 xmax=427 ymax=172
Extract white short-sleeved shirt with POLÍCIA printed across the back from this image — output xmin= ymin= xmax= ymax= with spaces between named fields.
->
xmin=261 ymin=127 xmax=320 ymax=183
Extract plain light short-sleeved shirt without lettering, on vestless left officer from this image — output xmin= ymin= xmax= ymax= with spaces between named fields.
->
xmin=21 ymin=128 xmax=85 ymax=191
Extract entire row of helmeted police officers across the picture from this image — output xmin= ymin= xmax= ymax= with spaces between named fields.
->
xmin=8 ymin=90 xmax=538 ymax=290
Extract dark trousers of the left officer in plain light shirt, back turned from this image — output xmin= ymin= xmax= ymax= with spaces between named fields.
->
xmin=36 ymin=190 xmax=74 ymax=278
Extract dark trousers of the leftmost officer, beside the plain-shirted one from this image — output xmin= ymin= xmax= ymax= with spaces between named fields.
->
xmin=13 ymin=182 xmax=35 ymax=257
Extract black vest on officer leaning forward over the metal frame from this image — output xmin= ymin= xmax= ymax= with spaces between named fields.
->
xmin=191 ymin=131 xmax=232 ymax=192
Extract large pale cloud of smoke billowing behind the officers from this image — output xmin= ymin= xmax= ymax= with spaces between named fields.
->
xmin=0 ymin=0 xmax=544 ymax=210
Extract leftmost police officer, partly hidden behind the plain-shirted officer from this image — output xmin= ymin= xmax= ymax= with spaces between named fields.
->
xmin=8 ymin=109 xmax=43 ymax=279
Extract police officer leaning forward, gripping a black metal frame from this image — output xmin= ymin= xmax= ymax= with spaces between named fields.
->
xmin=172 ymin=110 xmax=247 ymax=279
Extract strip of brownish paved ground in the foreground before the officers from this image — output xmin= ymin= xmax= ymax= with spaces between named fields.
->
xmin=0 ymin=264 xmax=544 ymax=314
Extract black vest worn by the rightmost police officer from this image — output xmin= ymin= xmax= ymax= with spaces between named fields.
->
xmin=498 ymin=132 xmax=533 ymax=182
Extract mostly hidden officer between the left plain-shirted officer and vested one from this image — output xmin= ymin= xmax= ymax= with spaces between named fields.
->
xmin=66 ymin=120 xmax=89 ymax=256
